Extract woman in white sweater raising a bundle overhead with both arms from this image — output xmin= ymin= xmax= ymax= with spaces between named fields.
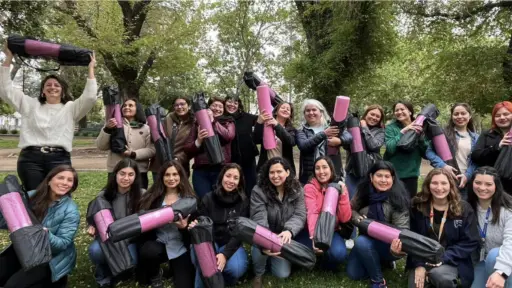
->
xmin=0 ymin=46 xmax=97 ymax=191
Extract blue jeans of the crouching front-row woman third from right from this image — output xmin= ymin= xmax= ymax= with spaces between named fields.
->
xmin=347 ymin=235 xmax=397 ymax=282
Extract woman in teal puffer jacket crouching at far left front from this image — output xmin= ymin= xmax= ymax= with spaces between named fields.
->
xmin=0 ymin=165 xmax=80 ymax=288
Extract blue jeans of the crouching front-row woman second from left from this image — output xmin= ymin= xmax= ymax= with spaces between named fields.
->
xmin=89 ymin=239 xmax=137 ymax=286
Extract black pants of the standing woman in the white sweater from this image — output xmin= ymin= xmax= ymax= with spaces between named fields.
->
xmin=17 ymin=149 xmax=71 ymax=191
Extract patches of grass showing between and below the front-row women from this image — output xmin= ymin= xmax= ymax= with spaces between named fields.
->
xmin=0 ymin=172 xmax=410 ymax=288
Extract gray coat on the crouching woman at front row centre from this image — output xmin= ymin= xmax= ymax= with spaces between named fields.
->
xmin=251 ymin=185 xmax=306 ymax=237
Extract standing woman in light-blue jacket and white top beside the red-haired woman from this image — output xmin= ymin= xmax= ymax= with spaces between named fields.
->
xmin=426 ymin=103 xmax=478 ymax=199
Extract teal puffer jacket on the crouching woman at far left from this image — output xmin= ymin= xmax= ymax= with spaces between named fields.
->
xmin=0 ymin=190 xmax=80 ymax=282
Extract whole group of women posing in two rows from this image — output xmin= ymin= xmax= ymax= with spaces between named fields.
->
xmin=0 ymin=41 xmax=512 ymax=288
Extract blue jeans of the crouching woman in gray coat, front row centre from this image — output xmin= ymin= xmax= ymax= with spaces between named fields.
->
xmin=251 ymin=246 xmax=292 ymax=279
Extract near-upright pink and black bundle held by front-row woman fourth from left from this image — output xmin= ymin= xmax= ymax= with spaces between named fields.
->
xmin=190 ymin=216 xmax=224 ymax=288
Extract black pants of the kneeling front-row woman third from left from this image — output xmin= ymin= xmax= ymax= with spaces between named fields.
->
xmin=137 ymin=240 xmax=195 ymax=288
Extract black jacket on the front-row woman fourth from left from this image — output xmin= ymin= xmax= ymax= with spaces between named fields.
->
xmin=199 ymin=189 xmax=249 ymax=259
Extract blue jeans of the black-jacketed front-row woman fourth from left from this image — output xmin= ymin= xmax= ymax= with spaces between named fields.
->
xmin=190 ymin=244 xmax=249 ymax=288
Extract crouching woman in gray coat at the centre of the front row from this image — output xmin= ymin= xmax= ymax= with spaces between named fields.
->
xmin=251 ymin=157 xmax=306 ymax=288
